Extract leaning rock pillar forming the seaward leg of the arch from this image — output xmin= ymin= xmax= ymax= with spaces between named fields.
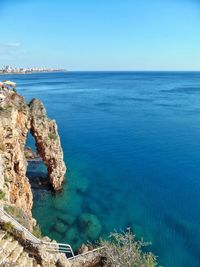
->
xmin=30 ymin=99 xmax=66 ymax=190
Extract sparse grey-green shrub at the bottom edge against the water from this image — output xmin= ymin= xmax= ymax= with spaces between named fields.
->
xmin=100 ymin=228 xmax=158 ymax=267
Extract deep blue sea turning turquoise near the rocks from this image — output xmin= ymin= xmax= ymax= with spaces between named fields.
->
xmin=3 ymin=72 xmax=200 ymax=267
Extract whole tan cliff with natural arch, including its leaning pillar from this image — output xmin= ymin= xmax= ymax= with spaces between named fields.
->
xmin=0 ymin=89 xmax=66 ymax=220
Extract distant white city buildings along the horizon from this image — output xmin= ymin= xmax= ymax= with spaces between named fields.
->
xmin=0 ymin=65 xmax=65 ymax=74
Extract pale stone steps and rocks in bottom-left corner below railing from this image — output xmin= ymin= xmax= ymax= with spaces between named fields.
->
xmin=0 ymin=221 xmax=71 ymax=267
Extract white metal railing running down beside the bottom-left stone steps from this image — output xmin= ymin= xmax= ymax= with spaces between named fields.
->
xmin=0 ymin=207 xmax=74 ymax=258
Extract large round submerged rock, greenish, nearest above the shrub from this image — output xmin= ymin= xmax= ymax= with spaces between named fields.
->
xmin=79 ymin=213 xmax=102 ymax=240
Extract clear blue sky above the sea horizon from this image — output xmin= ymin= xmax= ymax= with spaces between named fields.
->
xmin=0 ymin=0 xmax=200 ymax=70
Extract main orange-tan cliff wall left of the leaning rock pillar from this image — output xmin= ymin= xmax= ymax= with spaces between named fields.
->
xmin=0 ymin=90 xmax=33 ymax=217
